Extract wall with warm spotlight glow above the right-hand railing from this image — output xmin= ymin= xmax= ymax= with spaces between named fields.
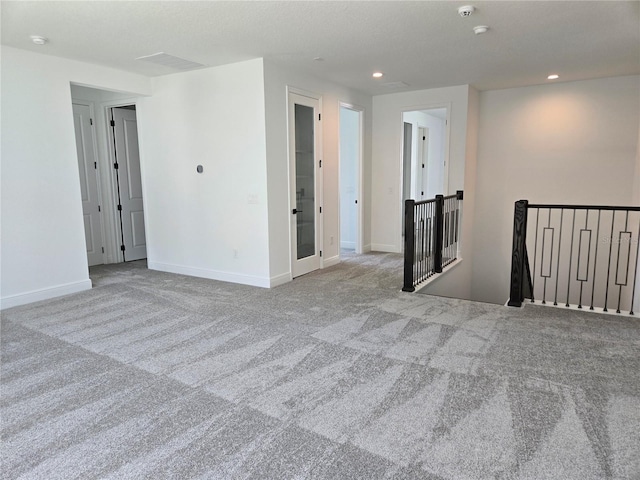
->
xmin=472 ymin=76 xmax=640 ymax=303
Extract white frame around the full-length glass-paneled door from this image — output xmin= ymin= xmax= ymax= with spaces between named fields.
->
xmin=286 ymin=85 xmax=324 ymax=278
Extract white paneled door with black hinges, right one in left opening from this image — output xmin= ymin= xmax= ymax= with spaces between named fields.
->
xmin=111 ymin=108 xmax=147 ymax=261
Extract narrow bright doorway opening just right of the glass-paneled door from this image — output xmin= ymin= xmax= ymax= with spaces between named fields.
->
xmin=339 ymin=103 xmax=363 ymax=254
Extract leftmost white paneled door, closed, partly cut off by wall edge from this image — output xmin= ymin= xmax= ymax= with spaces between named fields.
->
xmin=73 ymin=103 xmax=104 ymax=266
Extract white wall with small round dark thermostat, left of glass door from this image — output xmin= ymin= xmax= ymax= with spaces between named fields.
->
xmin=137 ymin=59 xmax=270 ymax=287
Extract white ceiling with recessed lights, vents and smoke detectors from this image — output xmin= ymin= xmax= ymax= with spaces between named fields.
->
xmin=1 ymin=0 xmax=640 ymax=95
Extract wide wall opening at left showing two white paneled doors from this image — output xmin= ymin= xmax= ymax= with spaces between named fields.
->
xmin=71 ymin=84 xmax=147 ymax=267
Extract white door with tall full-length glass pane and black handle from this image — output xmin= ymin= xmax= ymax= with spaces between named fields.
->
xmin=289 ymin=93 xmax=322 ymax=277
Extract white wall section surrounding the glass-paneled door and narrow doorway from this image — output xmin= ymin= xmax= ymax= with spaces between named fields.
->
xmin=264 ymin=60 xmax=372 ymax=284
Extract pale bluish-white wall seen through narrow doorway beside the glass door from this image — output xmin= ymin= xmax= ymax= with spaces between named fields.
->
xmin=339 ymin=108 xmax=360 ymax=249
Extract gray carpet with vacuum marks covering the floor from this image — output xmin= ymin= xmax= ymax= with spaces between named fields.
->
xmin=1 ymin=254 xmax=640 ymax=480
